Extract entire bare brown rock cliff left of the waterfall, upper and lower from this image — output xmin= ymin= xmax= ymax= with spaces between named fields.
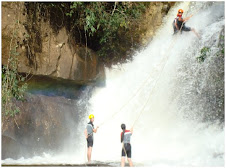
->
xmin=2 ymin=2 xmax=175 ymax=159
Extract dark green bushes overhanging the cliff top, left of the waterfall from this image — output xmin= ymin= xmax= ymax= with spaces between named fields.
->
xmin=25 ymin=2 xmax=150 ymax=65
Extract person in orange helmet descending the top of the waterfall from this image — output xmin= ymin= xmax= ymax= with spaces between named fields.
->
xmin=173 ymin=9 xmax=200 ymax=38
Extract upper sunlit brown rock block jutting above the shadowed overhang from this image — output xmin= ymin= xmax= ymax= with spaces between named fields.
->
xmin=2 ymin=2 xmax=104 ymax=83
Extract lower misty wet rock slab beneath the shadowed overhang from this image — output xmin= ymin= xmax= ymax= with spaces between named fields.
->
xmin=2 ymin=90 xmax=91 ymax=159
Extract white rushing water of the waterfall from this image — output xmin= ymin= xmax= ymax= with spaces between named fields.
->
xmin=3 ymin=2 xmax=225 ymax=167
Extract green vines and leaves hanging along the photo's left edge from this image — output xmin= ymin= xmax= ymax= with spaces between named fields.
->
xmin=2 ymin=21 xmax=27 ymax=118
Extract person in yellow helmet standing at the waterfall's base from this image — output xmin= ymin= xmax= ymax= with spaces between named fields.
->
xmin=84 ymin=114 xmax=99 ymax=163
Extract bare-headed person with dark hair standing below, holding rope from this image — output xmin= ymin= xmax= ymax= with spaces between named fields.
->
xmin=121 ymin=124 xmax=133 ymax=167
